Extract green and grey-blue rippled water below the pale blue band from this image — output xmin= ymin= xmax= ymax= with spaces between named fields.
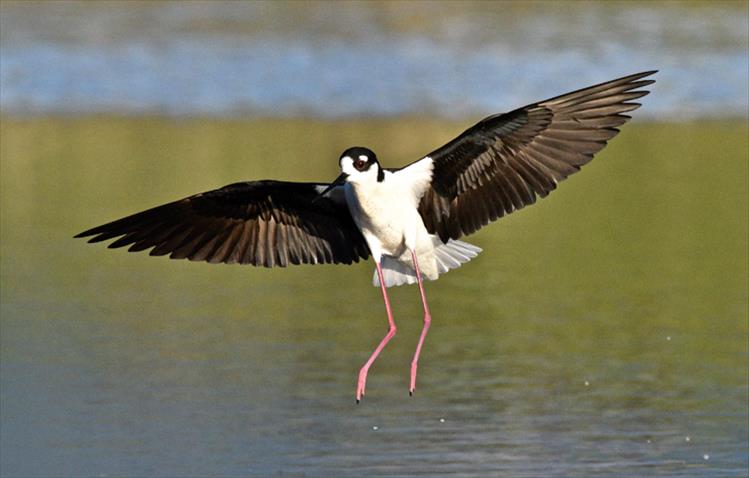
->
xmin=0 ymin=117 xmax=749 ymax=477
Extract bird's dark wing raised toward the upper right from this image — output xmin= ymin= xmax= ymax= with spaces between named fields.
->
xmin=412 ymin=71 xmax=656 ymax=242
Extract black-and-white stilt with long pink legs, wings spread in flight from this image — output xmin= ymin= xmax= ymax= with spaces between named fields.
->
xmin=76 ymin=71 xmax=655 ymax=402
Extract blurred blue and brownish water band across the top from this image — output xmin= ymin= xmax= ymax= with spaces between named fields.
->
xmin=0 ymin=1 xmax=749 ymax=121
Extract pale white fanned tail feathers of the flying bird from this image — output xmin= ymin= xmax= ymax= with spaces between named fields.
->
xmin=372 ymin=238 xmax=481 ymax=287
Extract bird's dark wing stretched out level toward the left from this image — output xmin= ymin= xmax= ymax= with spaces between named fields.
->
xmin=75 ymin=181 xmax=369 ymax=267
